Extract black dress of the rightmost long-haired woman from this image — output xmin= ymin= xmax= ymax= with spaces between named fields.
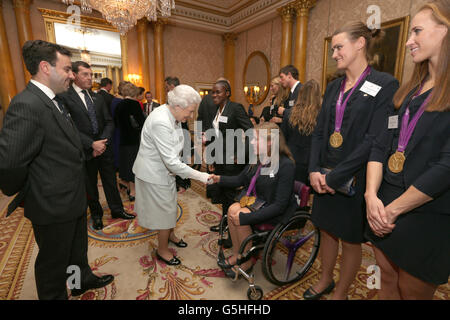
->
xmin=366 ymin=91 xmax=450 ymax=285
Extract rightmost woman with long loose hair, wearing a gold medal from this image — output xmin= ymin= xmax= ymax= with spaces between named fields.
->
xmin=365 ymin=0 xmax=450 ymax=300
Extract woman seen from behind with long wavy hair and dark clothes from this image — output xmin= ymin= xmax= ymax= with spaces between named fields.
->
xmin=281 ymin=80 xmax=321 ymax=183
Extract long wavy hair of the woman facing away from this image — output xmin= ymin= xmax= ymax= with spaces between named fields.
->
xmin=289 ymin=80 xmax=321 ymax=136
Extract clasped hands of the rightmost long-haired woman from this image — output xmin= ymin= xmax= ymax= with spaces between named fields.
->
xmin=364 ymin=193 xmax=397 ymax=237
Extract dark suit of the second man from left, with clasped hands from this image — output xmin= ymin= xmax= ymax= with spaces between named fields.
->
xmin=60 ymin=86 xmax=123 ymax=218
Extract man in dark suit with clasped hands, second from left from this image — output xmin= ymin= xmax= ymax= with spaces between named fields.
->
xmin=61 ymin=61 xmax=135 ymax=230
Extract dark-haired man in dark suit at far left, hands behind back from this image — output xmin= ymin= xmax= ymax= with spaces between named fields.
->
xmin=0 ymin=40 xmax=114 ymax=299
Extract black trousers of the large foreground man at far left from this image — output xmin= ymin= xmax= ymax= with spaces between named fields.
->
xmin=33 ymin=214 xmax=93 ymax=300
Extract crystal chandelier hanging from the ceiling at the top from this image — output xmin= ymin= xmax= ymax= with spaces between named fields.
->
xmin=61 ymin=0 xmax=175 ymax=35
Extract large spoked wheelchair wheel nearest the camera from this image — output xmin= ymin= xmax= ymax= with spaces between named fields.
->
xmin=262 ymin=211 xmax=320 ymax=286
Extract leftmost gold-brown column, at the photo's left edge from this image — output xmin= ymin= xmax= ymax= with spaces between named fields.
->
xmin=0 ymin=1 xmax=17 ymax=114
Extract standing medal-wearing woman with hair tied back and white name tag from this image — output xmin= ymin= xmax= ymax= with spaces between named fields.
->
xmin=303 ymin=22 xmax=398 ymax=300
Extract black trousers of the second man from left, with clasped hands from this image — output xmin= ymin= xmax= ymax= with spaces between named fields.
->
xmin=86 ymin=147 xmax=123 ymax=218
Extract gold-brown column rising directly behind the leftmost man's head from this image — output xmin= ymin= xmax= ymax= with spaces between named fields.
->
xmin=13 ymin=0 xmax=33 ymax=83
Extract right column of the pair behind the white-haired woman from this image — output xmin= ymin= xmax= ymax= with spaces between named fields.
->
xmin=153 ymin=19 xmax=168 ymax=104
